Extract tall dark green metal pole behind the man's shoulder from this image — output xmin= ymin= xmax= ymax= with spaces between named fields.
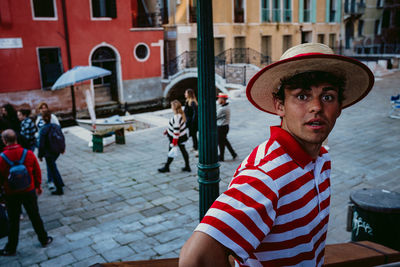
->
xmin=197 ymin=0 xmax=220 ymax=220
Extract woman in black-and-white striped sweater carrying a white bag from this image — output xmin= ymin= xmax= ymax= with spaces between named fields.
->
xmin=158 ymin=100 xmax=191 ymax=172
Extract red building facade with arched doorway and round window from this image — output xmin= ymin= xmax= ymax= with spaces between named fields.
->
xmin=0 ymin=0 xmax=163 ymax=118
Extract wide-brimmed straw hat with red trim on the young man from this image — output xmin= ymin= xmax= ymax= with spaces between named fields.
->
xmin=246 ymin=43 xmax=374 ymax=114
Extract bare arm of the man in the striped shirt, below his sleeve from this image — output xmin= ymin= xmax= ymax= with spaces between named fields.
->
xmin=179 ymin=232 xmax=231 ymax=267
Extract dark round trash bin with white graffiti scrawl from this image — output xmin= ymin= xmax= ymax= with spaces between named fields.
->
xmin=350 ymin=189 xmax=400 ymax=251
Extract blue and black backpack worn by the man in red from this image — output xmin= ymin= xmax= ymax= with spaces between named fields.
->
xmin=0 ymin=149 xmax=31 ymax=191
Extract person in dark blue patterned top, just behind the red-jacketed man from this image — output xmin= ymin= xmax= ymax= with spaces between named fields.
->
xmin=18 ymin=109 xmax=37 ymax=151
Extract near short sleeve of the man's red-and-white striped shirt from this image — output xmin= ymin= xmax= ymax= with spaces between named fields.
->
xmin=195 ymin=169 xmax=278 ymax=261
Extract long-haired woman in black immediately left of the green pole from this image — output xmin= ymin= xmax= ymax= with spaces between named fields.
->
xmin=185 ymin=88 xmax=198 ymax=155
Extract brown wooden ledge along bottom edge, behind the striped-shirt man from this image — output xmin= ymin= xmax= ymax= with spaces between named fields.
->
xmin=92 ymin=241 xmax=400 ymax=267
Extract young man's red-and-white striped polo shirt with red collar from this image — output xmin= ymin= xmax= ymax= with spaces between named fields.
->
xmin=195 ymin=127 xmax=331 ymax=266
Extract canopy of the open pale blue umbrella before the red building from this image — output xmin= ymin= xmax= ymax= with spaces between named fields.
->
xmin=51 ymin=66 xmax=111 ymax=90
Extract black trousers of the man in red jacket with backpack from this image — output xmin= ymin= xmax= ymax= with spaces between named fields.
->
xmin=5 ymin=190 xmax=48 ymax=252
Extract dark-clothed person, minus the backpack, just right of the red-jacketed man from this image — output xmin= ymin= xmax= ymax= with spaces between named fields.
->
xmin=38 ymin=111 xmax=64 ymax=195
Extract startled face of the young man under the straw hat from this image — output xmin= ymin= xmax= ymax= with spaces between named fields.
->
xmin=275 ymin=83 xmax=342 ymax=151
